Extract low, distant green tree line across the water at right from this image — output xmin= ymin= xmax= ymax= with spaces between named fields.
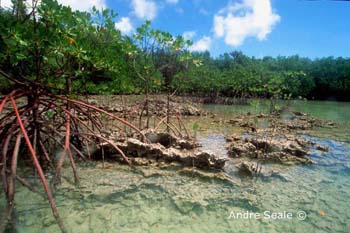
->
xmin=174 ymin=51 xmax=350 ymax=100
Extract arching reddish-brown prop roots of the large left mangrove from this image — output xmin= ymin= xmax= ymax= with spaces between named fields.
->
xmin=0 ymin=86 xmax=148 ymax=232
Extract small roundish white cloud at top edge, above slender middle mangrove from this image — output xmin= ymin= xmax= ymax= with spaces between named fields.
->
xmin=131 ymin=0 xmax=157 ymax=20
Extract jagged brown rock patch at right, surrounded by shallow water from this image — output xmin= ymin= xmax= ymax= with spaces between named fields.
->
xmin=223 ymin=112 xmax=337 ymax=166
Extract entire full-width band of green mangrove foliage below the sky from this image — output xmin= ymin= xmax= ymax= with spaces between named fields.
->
xmin=0 ymin=0 xmax=350 ymax=100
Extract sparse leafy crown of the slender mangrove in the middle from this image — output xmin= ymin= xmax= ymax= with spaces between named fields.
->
xmin=130 ymin=21 xmax=191 ymax=92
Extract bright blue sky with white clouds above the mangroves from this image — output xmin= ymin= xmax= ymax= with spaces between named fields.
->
xmin=2 ymin=0 xmax=350 ymax=58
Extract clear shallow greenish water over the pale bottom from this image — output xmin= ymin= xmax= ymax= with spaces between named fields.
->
xmin=0 ymin=99 xmax=350 ymax=233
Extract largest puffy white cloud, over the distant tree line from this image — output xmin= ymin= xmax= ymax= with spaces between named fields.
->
xmin=214 ymin=0 xmax=280 ymax=47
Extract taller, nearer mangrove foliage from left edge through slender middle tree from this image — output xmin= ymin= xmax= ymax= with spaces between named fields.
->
xmin=0 ymin=0 xmax=189 ymax=94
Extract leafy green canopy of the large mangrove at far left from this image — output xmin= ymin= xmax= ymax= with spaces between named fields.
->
xmin=0 ymin=0 xmax=139 ymax=93
